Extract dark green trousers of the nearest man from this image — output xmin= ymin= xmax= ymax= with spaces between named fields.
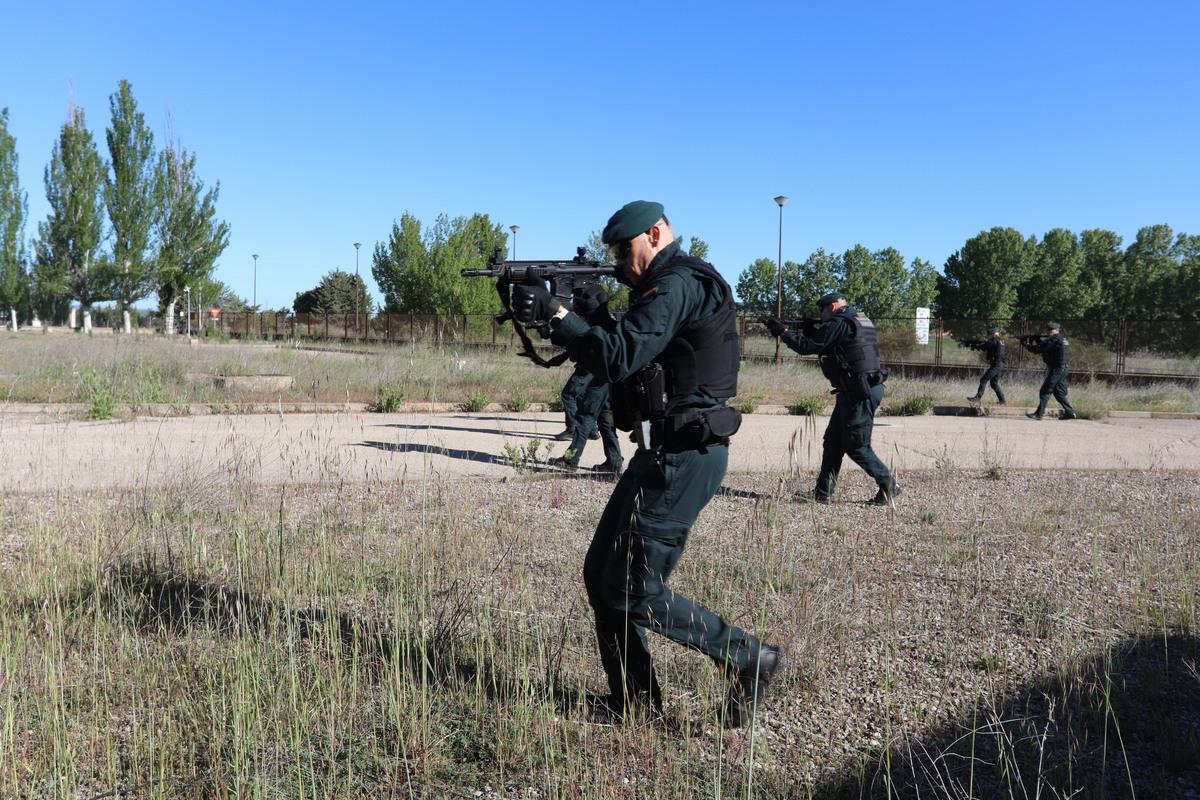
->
xmin=583 ymin=446 xmax=761 ymax=706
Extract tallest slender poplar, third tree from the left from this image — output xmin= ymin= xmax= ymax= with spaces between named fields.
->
xmin=104 ymin=80 xmax=157 ymax=333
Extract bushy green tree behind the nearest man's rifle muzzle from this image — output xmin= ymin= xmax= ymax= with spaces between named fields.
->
xmin=371 ymin=212 xmax=506 ymax=314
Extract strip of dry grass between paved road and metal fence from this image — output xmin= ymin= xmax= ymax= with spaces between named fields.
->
xmin=0 ymin=332 xmax=1200 ymax=416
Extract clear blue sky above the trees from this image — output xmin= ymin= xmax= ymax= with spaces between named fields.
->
xmin=0 ymin=0 xmax=1200 ymax=308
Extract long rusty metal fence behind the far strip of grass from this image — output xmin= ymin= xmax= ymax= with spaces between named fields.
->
xmin=193 ymin=312 xmax=1200 ymax=379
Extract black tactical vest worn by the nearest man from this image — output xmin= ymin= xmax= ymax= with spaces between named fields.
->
xmin=655 ymin=255 xmax=742 ymax=408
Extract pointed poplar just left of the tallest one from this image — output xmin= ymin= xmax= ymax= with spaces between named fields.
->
xmin=36 ymin=106 xmax=108 ymax=331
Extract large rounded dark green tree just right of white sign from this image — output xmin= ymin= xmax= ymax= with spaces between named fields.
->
xmin=937 ymin=228 xmax=1037 ymax=319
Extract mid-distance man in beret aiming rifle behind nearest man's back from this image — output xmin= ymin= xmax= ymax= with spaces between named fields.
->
xmin=764 ymin=291 xmax=901 ymax=505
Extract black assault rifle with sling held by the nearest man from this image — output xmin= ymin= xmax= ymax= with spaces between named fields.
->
xmin=462 ymin=247 xmax=617 ymax=367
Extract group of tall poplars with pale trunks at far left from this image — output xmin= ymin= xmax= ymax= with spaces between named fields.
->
xmin=0 ymin=80 xmax=234 ymax=332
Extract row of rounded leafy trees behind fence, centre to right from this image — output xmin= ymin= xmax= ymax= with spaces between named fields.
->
xmin=355 ymin=213 xmax=1200 ymax=328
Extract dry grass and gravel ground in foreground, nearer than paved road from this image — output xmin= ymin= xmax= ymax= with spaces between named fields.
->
xmin=0 ymin=460 xmax=1200 ymax=798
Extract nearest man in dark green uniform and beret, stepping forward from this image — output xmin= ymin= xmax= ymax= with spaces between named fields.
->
xmin=512 ymin=200 xmax=784 ymax=727
